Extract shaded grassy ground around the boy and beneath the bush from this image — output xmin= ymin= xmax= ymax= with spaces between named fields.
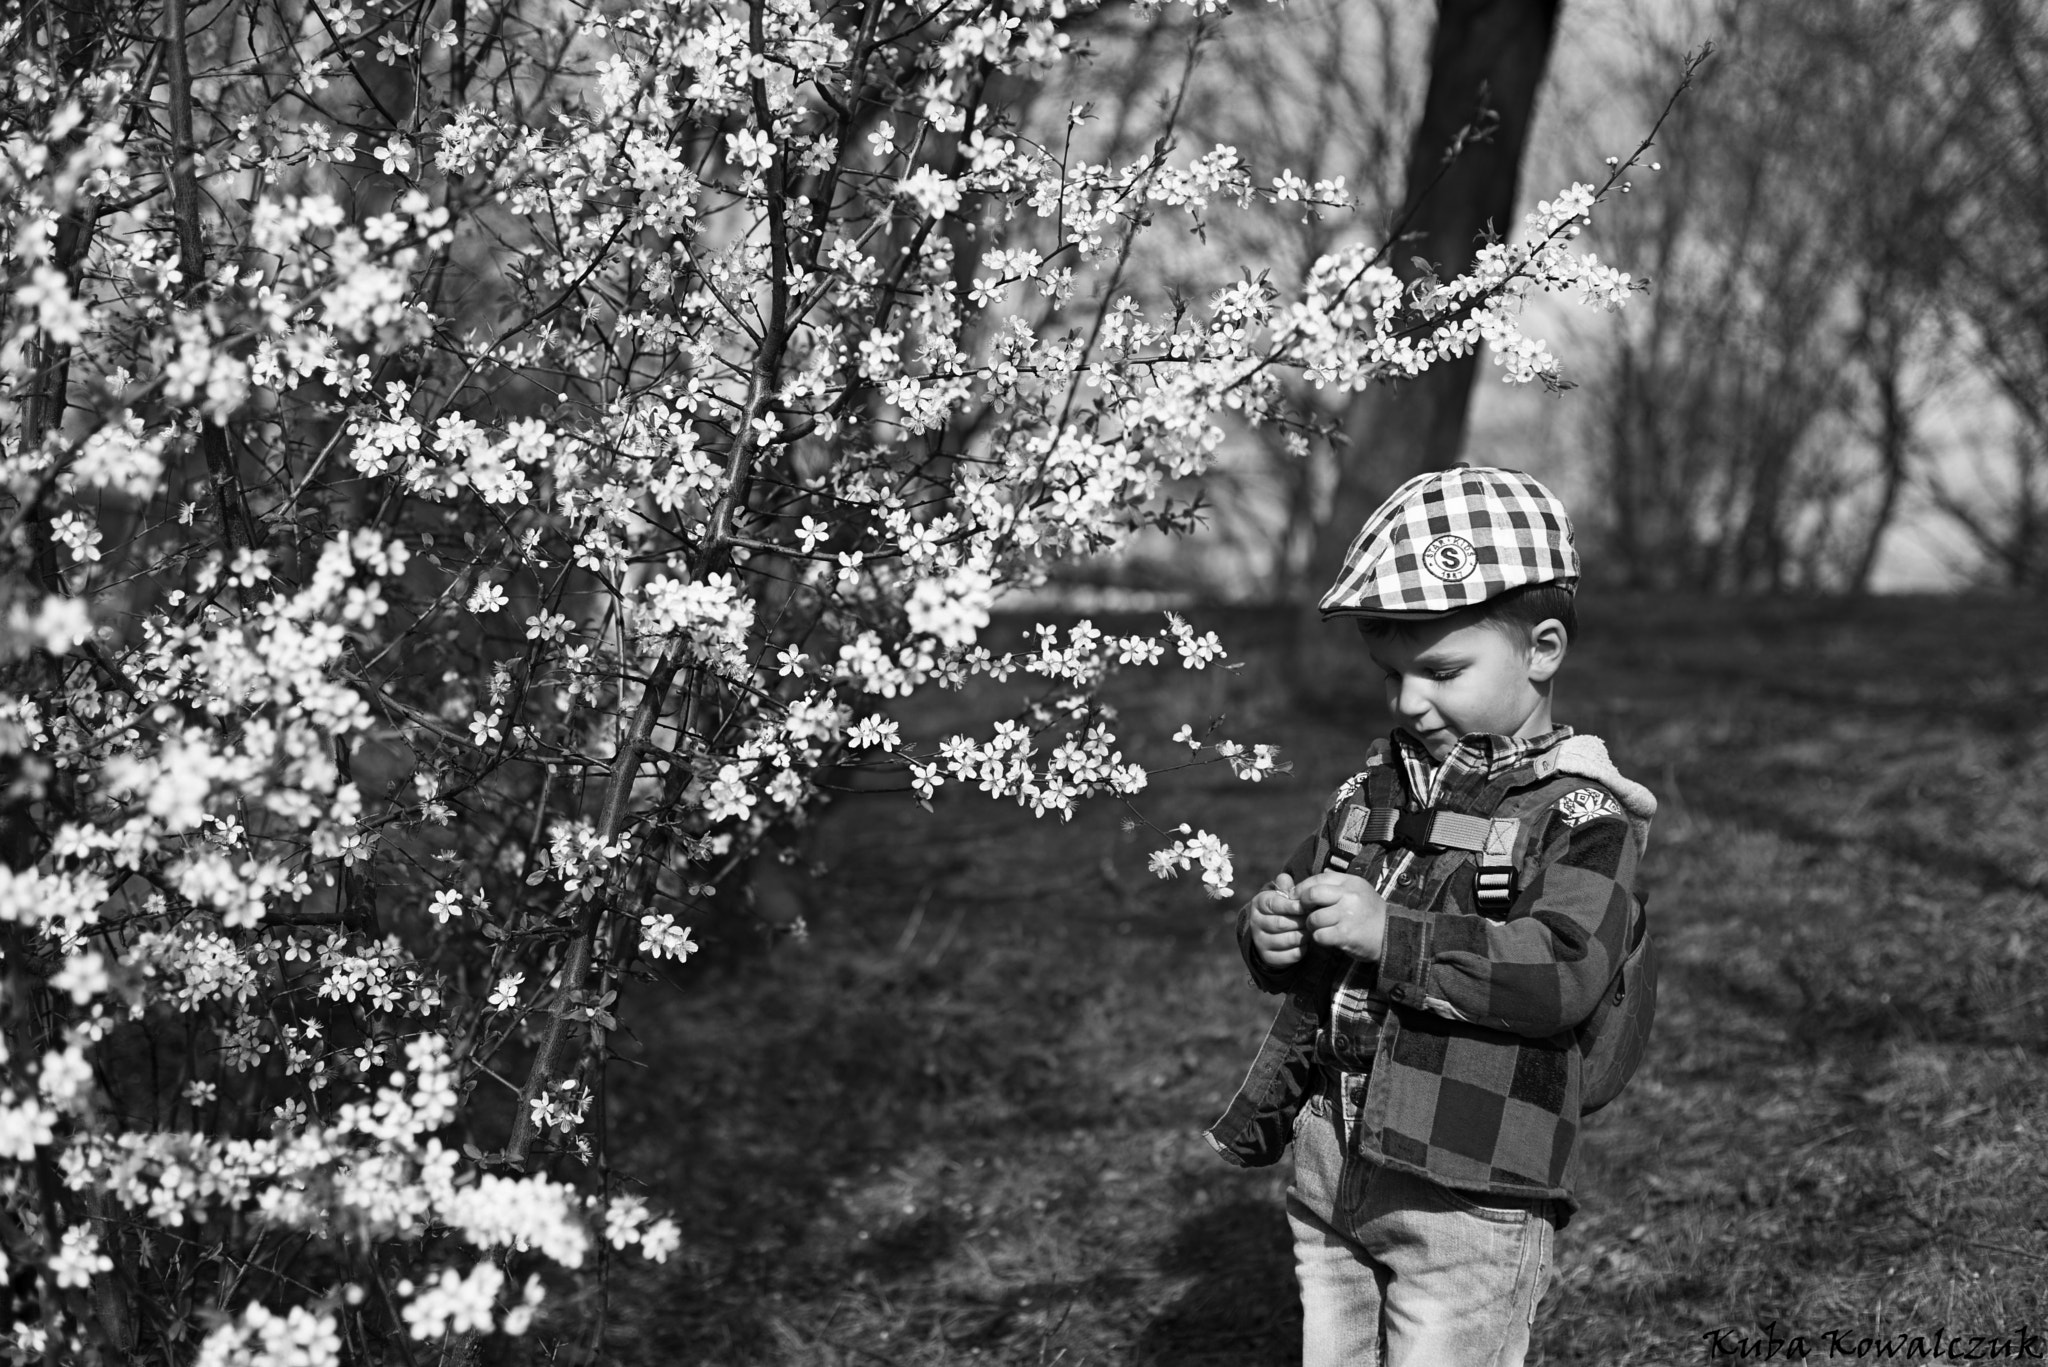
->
xmin=608 ymin=600 xmax=2048 ymax=1367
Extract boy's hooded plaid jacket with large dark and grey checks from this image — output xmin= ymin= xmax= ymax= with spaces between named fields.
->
xmin=1206 ymin=728 xmax=1655 ymax=1211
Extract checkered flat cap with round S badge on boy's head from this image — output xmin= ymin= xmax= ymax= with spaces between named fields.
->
xmin=1317 ymin=465 xmax=1579 ymax=617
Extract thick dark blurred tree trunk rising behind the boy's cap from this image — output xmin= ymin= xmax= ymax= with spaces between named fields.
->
xmin=1309 ymin=0 xmax=1563 ymax=592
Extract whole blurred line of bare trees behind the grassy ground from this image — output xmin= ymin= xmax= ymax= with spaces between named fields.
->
xmin=1094 ymin=0 xmax=2048 ymax=596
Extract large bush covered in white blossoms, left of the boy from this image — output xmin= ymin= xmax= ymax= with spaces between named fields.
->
xmin=0 ymin=0 xmax=1630 ymax=1365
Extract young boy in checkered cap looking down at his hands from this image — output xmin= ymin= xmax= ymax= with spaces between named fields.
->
xmin=1208 ymin=467 xmax=1657 ymax=1367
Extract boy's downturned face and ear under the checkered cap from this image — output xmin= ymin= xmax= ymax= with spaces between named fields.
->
xmin=1366 ymin=617 xmax=1565 ymax=762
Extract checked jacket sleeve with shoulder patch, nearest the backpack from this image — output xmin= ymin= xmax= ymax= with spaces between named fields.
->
xmin=1378 ymin=799 xmax=1638 ymax=1039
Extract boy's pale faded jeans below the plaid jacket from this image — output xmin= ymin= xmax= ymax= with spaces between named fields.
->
xmin=1286 ymin=1074 xmax=1556 ymax=1367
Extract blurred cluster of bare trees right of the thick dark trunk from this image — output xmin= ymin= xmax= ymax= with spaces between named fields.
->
xmin=1548 ymin=0 xmax=2044 ymax=592
